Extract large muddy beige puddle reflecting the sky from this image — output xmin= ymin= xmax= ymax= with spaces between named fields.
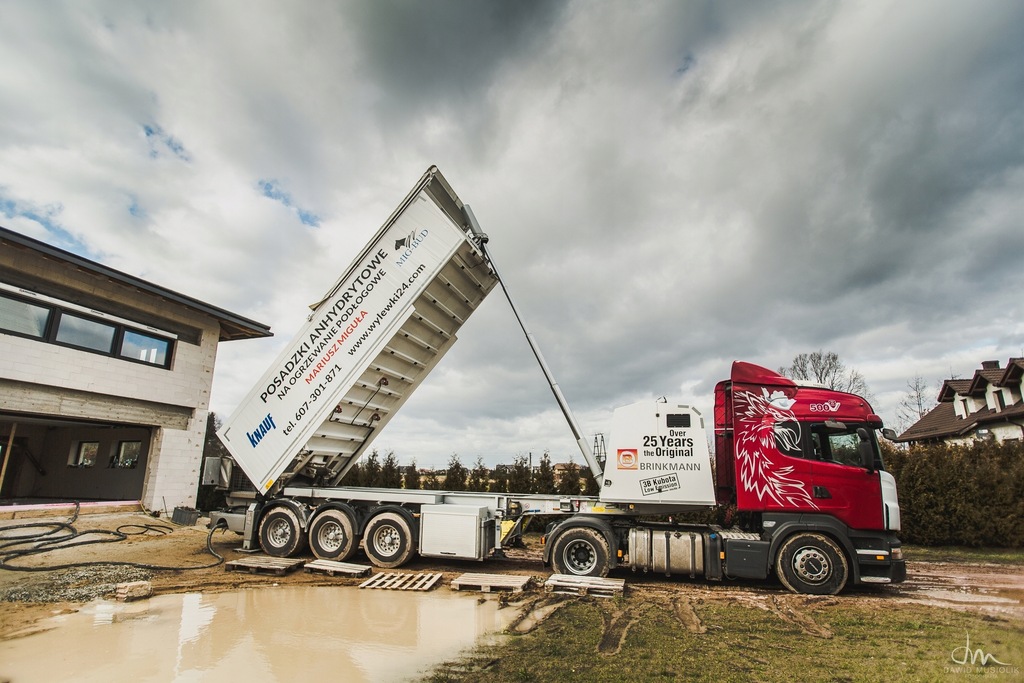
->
xmin=0 ymin=587 xmax=516 ymax=683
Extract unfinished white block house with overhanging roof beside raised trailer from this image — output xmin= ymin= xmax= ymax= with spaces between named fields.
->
xmin=0 ymin=228 xmax=270 ymax=510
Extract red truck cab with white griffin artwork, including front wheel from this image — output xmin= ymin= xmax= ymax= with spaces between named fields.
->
xmin=715 ymin=361 xmax=906 ymax=593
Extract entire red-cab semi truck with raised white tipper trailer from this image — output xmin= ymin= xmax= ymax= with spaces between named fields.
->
xmin=204 ymin=167 xmax=906 ymax=594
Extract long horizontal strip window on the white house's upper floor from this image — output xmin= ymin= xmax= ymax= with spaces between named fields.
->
xmin=0 ymin=292 xmax=174 ymax=368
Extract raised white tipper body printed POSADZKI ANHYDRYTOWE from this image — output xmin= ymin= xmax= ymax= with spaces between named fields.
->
xmin=218 ymin=168 xmax=498 ymax=493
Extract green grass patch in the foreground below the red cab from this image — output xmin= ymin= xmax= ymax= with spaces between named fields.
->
xmin=427 ymin=595 xmax=1024 ymax=683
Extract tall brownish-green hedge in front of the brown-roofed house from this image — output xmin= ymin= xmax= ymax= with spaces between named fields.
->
xmin=883 ymin=441 xmax=1024 ymax=548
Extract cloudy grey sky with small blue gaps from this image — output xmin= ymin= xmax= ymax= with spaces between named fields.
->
xmin=0 ymin=0 xmax=1024 ymax=466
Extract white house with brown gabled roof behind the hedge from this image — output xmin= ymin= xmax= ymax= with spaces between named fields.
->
xmin=897 ymin=358 xmax=1024 ymax=443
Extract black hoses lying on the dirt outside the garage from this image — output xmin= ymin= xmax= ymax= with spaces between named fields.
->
xmin=0 ymin=503 xmax=227 ymax=571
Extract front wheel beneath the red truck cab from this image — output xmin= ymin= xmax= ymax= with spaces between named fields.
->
xmin=775 ymin=533 xmax=850 ymax=595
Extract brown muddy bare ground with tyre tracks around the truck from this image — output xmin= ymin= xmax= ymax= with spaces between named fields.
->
xmin=0 ymin=513 xmax=1024 ymax=650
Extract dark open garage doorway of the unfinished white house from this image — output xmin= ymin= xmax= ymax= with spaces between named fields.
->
xmin=0 ymin=415 xmax=154 ymax=505
